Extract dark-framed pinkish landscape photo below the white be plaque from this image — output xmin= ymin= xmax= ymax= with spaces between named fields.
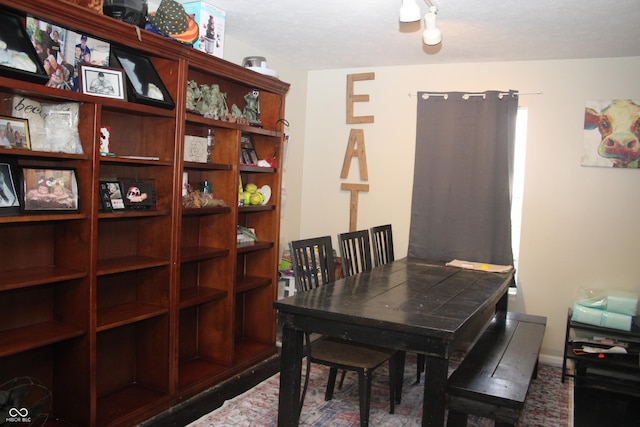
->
xmin=21 ymin=167 xmax=79 ymax=212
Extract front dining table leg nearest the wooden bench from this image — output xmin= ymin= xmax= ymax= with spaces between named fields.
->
xmin=422 ymin=356 xmax=449 ymax=427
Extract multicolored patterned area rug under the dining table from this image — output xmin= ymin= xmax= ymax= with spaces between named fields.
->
xmin=189 ymin=354 xmax=573 ymax=427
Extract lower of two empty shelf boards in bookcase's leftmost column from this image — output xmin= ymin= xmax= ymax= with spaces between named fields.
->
xmin=0 ymin=321 xmax=86 ymax=357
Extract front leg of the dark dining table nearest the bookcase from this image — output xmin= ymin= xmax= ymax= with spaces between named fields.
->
xmin=278 ymin=327 xmax=303 ymax=427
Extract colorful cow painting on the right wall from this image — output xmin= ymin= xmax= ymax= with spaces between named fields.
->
xmin=582 ymin=99 xmax=640 ymax=168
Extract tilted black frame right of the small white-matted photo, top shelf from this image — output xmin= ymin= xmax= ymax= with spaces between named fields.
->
xmin=110 ymin=46 xmax=175 ymax=110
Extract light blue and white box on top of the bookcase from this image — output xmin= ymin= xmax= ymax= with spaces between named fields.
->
xmin=180 ymin=0 xmax=226 ymax=58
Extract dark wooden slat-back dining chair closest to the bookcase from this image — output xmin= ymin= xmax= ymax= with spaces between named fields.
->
xmin=289 ymin=236 xmax=404 ymax=426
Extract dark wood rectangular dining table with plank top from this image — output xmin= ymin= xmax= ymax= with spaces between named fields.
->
xmin=274 ymin=258 xmax=513 ymax=426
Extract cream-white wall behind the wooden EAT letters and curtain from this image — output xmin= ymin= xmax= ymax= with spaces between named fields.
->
xmin=225 ymin=36 xmax=640 ymax=358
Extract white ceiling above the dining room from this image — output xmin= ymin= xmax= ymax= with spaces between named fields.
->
xmin=208 ymin=0 xmax=640 ymax=70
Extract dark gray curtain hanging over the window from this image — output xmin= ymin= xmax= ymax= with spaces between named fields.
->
xmin=408 ymin=91 xmax=518 ymax=265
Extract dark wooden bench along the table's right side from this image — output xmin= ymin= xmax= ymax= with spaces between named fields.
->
xmin=447 ymin=312 xmax=547 ymax=427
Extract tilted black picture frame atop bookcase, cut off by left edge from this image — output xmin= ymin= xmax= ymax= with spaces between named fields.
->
xmin=0 ymin=10 xmax=49 ymax=84
